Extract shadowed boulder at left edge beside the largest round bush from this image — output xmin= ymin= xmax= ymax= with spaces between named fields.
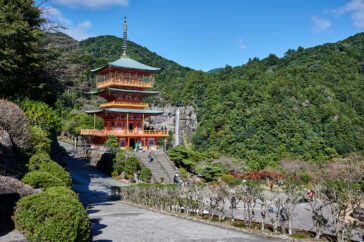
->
xmin=0 ymin=176 xmax=41 ymax=233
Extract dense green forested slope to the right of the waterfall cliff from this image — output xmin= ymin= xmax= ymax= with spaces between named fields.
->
xmin=191 ymin=33 xmax=364 ymax=169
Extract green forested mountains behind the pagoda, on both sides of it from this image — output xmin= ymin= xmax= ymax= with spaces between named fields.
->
xmin=44 ymin=33 xmax=364 ymax=169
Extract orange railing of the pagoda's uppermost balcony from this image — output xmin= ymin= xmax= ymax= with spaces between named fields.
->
xmin=97 ymin=75 xmax=153 ymax=88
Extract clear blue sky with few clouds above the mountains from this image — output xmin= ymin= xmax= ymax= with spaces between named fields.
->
xmin=42 ymin=0 xmax=364 ymax=71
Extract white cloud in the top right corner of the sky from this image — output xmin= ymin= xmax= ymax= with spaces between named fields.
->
xmin=332 ymin=0 xmax=364 ymax=28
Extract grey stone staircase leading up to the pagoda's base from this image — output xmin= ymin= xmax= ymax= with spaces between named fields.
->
xmin=134 ymin=150 xmax=178 ymax=184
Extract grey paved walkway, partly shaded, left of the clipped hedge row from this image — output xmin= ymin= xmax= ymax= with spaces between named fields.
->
xmin=61 ymin=143 xmax=273 ymax=242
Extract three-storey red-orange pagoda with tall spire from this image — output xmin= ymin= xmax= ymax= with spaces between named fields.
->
xmin=81 ymin=19 xmax=168 ymax=150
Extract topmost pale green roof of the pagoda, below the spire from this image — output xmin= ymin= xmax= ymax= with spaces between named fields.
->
xmin=91 ymin=57 xmax=161 ymax=73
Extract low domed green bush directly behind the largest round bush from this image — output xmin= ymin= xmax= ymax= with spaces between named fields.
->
xmin=21 ymin=171 xmax=67 ymax=190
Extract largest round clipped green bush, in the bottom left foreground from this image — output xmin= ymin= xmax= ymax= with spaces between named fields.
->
xmin=14 ymin=187 xmax=90 ymax=241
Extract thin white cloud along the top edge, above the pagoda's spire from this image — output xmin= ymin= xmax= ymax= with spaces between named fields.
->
xmin=53 ymin=0 xmax=129 ymax=9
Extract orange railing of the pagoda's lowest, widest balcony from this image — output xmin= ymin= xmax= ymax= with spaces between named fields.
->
xmin=81 ymin=129 xmax=169 ymax=138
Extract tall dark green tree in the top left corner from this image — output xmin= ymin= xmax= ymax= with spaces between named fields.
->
xmin=0 ymin=0 xmax=54 ymax=99
